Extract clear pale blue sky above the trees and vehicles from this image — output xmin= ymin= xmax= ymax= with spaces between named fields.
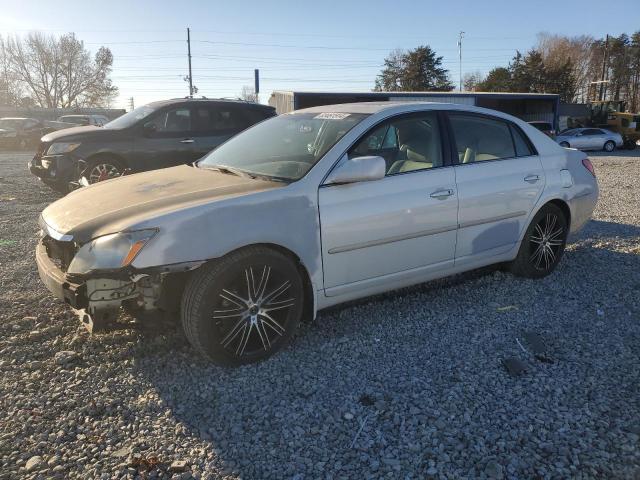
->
xmin=0 ymin=0 xmax=640 ymax=109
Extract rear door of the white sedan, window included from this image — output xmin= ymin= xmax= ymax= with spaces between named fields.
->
xmin=448 ymin=112 xmax=545 ymax=264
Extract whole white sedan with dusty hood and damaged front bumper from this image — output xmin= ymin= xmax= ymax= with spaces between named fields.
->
xmin=36 ymin=102 xmax=598 ymax=365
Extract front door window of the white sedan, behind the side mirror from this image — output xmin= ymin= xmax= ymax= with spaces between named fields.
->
xmin=348 ymin=112 xmax=443 ymax=175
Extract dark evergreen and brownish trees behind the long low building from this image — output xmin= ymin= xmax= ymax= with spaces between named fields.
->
xmin=374 ymin=31 xmax=640 ymax=112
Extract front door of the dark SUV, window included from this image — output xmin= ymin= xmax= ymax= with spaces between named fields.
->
xmin=132 ymin=105 xmax=197 ymax=170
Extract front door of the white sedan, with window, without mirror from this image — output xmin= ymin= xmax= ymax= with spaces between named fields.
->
xmin=319 ymin=112 xmax=458 ymax=296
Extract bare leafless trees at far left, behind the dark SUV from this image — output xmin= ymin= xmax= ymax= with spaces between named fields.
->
xmin=5 ymin=32 xmax=118 ymax=108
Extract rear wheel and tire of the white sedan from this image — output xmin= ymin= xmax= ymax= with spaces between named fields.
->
xmin=509 ymin=203 xmax=568 ymax=278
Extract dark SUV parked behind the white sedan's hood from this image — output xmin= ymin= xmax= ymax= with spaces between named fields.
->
xmin=30 ymin=98 xmax=276 ymax=193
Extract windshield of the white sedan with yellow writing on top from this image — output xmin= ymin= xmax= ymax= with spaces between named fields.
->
xmin=198 ymin=112 xmax=367 ymax=181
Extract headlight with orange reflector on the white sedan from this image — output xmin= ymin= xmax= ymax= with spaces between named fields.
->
xmin=67 ymin=230 xmax=157 ymax=274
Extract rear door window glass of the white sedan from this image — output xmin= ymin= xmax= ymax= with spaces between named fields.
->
xmin=449 ymin=113 xmax=516 ymax=163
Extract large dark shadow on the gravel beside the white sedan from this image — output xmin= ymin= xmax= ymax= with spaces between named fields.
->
xmin=131 ymin=221 xmax=640 ymax=478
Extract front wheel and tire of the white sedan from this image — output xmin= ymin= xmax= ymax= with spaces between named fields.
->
xmin=182 ymin=247 xmax=304 ymax=366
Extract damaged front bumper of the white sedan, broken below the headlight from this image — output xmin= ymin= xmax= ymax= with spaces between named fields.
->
xmin=36 ymin=237 xmax=202 ymax=332
